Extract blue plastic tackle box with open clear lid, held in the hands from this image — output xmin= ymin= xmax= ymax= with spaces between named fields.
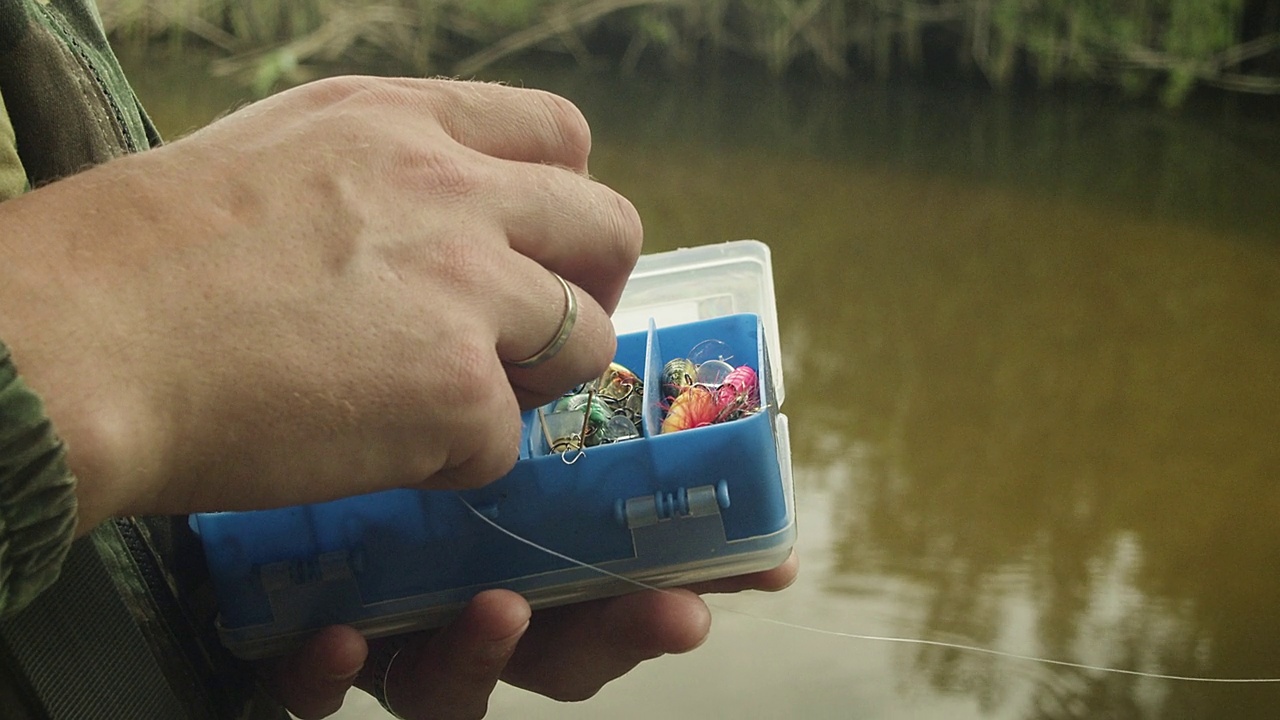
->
xmin=191 ymin=241 xmax=796 ymax=659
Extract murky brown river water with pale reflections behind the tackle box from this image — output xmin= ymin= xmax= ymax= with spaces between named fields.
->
xmin=120 ymin=50 xmax=1280 ymax=720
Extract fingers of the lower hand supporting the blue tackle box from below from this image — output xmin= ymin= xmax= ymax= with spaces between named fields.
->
xmin=262 ymin=555 xmax=797 ymax=720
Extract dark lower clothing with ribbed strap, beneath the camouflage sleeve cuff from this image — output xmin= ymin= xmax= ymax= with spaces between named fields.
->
xmin=0 ymin=518 xmax=287 ymax=720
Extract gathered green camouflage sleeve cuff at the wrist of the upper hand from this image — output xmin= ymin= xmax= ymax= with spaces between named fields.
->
xmin=0 ymin=342 xmax=76 ymax=616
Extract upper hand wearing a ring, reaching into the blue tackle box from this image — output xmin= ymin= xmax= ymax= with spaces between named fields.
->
xmin=0 ymin=77 xmax=641 ymax=532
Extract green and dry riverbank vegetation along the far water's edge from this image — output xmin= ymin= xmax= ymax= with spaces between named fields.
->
xmin=100 ymin=0 xmax=1280 ymax=105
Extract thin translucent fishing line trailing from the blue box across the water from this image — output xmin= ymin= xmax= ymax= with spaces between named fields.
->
xmin=454 ymin=493 xmax=1280 ymax=684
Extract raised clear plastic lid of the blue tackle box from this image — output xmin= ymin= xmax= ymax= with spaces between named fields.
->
xmin=613 ymin=240 xmax=783 ymax=405
